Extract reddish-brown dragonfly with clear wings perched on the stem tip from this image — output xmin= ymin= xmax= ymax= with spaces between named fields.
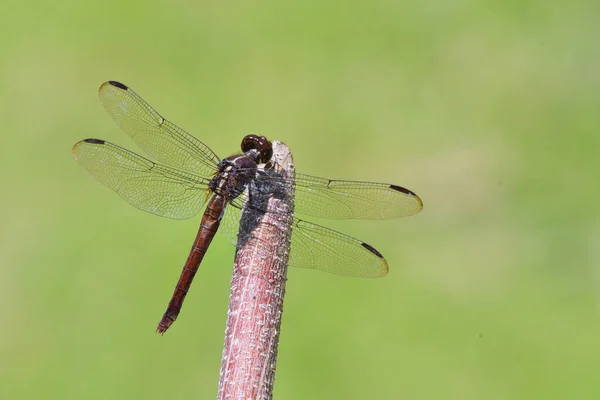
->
xmin=72 ymin=81 xmax=423 ymax=334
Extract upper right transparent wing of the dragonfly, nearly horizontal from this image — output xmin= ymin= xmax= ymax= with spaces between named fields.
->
xmin=229 ymin=174 xmax=423 ymax=219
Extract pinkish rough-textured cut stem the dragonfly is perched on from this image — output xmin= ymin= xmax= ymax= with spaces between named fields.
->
xmin=218 ymin=141 xmax=294 ymax=400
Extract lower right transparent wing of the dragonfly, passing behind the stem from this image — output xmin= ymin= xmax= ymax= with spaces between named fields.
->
xmin=219 ymin=205 xmax=388 ymax=278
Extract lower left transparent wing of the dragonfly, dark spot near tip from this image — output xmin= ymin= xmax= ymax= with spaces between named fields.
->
xmin=73 ymin=139 xmax=209 ymax=219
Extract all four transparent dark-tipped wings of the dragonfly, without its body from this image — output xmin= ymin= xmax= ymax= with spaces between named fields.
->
xmin=73 ymin=81 xmax=423 ymax=277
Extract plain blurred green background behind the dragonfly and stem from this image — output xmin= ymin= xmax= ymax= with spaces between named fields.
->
xmin=0 ymin=0 xmax=600 ymax=399
